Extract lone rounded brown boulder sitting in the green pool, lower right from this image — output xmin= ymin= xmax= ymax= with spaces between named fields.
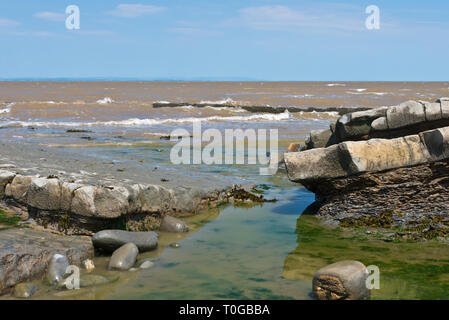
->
xmin=312 ymin=260 xmax=370 ymax=300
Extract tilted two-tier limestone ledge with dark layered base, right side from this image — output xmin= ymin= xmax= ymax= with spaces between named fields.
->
xmin=284 ymin=98 xmax=449 ymax=239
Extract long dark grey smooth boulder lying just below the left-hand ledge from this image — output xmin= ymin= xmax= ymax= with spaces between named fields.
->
xmin=92 ymin=230 xmax=158 ymax=252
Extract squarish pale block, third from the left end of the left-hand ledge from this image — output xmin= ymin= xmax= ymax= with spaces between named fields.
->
xmin=27 ymin=178 xmax=61 ymax=210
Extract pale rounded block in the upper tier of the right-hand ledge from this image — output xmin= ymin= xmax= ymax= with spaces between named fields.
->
xmin=387 ymin=100 xmax=426 ymax=130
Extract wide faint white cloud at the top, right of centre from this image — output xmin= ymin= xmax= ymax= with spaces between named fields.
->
xmin=226 ymin=5 xmax=365 ymax=31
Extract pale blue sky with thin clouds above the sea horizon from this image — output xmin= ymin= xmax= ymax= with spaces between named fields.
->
xmin=0 ymin=0 xmax=449 ymax=81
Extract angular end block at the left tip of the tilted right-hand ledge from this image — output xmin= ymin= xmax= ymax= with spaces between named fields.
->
xmin=284 ymin=145 xmax=346 ymax=182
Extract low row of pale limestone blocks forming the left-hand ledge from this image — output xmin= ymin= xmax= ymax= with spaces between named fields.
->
xmin=0 ymin=170 xmax=256 ymax=235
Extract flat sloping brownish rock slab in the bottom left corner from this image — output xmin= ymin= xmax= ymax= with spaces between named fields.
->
xmin=0 ymin=228 xmax=94 ymax=294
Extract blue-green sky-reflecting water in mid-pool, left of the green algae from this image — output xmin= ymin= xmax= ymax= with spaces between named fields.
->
xmin=106 ymin=189 xmax=313 ymax=299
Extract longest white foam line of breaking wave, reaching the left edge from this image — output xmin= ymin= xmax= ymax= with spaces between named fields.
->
xmin=0 ymin=110 xmax=294 ymax=127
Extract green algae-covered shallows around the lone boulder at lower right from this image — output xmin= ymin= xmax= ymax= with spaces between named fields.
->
xmin=283 ymin=216 xmax=449 ymax=299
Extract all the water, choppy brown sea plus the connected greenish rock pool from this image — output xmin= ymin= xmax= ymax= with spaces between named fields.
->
xmin=0 ymin=82 xmax=449 ymax=299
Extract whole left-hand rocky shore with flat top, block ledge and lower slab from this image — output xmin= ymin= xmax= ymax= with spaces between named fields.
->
xmin=0 ymin=141 xmax=272 ymax=294
